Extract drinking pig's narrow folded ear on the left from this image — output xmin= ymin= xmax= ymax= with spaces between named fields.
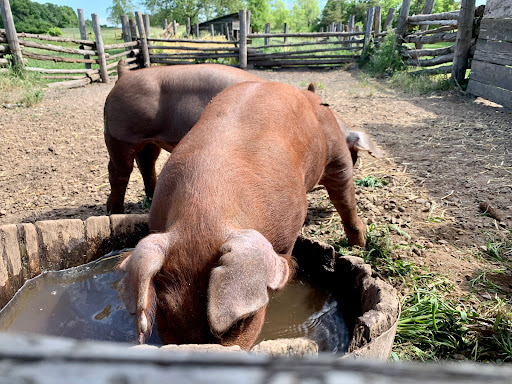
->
xmin=118 ymin=234 xmax=169 ymax=344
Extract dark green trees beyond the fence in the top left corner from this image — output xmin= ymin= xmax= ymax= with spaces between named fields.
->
xmin=0 ymin=0 xmax=78 ymax=33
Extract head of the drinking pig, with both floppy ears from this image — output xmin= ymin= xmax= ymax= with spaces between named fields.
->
xmin=119 ymin=229 xmax=290 ymax=349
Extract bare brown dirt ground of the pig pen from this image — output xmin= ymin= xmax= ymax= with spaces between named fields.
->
xmin=0 ymin=70 xmax=512 ymax=299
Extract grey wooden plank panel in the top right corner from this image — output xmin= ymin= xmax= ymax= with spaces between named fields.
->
xmin=468 ymin=0 xmax=512 ymax=109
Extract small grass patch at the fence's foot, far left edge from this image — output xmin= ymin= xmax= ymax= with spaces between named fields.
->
xmin=0 ymin=67 xmax=44 ymax=107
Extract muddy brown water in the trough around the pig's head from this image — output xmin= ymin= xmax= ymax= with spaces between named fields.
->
xmin=0 ymin=253 xmax=349 ymax=353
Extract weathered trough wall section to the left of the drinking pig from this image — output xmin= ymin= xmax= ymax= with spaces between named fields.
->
xmin=0 ymin=215 xmax=148 ymax=309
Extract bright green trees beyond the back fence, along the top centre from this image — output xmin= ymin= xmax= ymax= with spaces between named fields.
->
xmin=107 ymin=0 xmax=460 ymax=32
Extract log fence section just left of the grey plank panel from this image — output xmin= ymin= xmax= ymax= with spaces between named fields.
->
xmin=397 ymin=0 xmax=484 ymax=78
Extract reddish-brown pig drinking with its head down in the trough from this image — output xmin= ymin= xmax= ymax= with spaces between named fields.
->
xmin=120 ymin=82 xmax=365 ymax=349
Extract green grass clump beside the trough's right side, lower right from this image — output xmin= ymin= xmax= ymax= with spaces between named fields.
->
xmin=330 ymin=224 xmax=512 ymax=362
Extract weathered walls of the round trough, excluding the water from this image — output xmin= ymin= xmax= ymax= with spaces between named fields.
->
xmin=0 ymin=215 xmax=400 ymax=359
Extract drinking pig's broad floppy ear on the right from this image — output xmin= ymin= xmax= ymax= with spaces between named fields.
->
xmin=208 ymin=229 xmax=290 ymax=336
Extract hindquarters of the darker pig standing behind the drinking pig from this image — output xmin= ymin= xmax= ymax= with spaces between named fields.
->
xmin=104 ymin=61 xmax=264 ymax=213
